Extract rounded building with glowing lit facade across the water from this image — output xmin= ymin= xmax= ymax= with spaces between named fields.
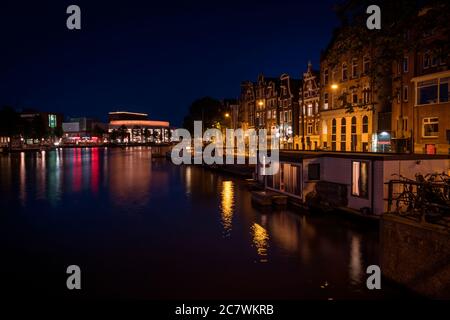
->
xmin=108 ymin=111 xmax=170 ymax=143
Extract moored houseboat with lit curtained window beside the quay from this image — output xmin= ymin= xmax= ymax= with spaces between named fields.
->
xmin=255 ymin=150 xmax=450 ymax=216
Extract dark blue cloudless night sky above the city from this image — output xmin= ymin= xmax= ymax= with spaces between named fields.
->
xmin=0 ymin=0 xmax=338 ymax=125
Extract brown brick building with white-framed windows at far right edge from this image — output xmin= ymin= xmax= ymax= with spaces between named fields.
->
xmin=392 ymin=13 xmax=450 ymax=154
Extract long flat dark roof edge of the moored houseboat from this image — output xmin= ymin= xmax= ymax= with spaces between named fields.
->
xmin=280 ymin=150 xmax=450 ymax=161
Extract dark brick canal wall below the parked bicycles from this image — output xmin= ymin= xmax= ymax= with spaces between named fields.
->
xmin=380 ymin=214 xmax=450 ymax=299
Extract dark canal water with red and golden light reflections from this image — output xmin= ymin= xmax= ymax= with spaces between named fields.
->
xmin=0 ymin=148 xmax=404 ymax=299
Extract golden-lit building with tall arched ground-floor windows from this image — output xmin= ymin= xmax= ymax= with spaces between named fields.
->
xmin=320 ymin=45 xmax=391 ymax=152
